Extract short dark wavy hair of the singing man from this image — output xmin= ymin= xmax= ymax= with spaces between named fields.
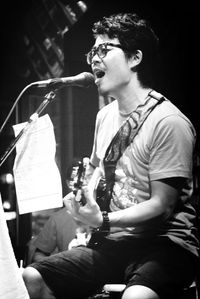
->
xmin=92 ymin=13 xmax=159 ymax=87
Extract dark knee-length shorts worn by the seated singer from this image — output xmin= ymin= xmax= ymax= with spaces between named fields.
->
xmin=29 ymin=237 xmax=195 ymax=299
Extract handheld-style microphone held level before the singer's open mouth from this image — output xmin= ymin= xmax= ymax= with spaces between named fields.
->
xmin=31 ymin=72 xmax=94 ymax=90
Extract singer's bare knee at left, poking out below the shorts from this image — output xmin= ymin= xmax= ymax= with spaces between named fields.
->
xmin=22 ymin=267 xmax=43 ymax=299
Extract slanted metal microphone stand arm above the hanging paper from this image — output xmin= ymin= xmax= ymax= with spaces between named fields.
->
xmin=0 ymin=91 xmax=56 ymax=167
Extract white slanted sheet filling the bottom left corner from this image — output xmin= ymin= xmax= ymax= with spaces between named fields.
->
xmin=0 ymin=194 xmax=29 ymax=299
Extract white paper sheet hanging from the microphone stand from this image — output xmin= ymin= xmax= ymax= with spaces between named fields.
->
xmin=13 ymin=114 xmax=63 ymax=214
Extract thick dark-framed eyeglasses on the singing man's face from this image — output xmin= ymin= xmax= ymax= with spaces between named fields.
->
xmin=86 ymin=43 xmax=122 ymax=65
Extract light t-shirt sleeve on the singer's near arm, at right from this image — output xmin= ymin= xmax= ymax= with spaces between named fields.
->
xmin=149 ymin=115 xmax=195 ymax=180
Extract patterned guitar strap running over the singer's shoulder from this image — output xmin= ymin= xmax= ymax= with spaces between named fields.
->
xmin=102 ymin=90 xmax=165 ymax=211
